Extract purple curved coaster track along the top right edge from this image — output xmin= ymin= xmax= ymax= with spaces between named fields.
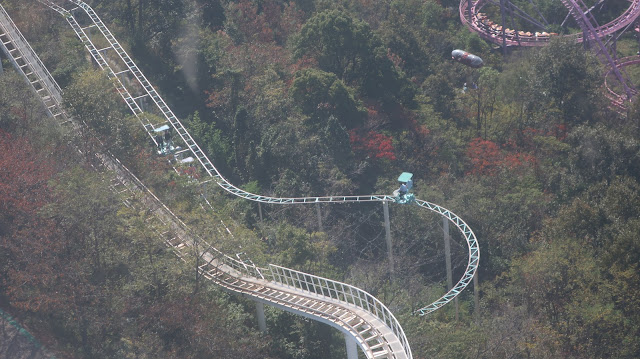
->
xmin=459 ymin=0 xmax=640 ymax=46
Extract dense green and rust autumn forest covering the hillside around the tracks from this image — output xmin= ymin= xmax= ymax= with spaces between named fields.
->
xmin=0 ymin=0 xmax=640 ymax=359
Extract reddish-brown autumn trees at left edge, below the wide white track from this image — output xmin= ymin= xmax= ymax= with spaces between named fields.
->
xmin=0 ymin=132 xmax=70 ymax=311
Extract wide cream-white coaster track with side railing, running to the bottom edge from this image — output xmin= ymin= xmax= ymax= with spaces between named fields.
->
xmin=0 ymin=2 xmax=420 ymax=359
